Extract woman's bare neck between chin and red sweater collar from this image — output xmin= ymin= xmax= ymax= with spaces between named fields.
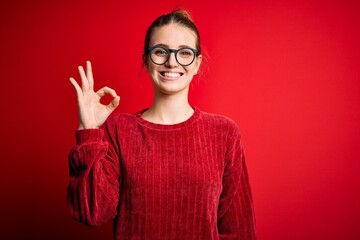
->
xmin=142 ymin=90 xmax=194 ymax=124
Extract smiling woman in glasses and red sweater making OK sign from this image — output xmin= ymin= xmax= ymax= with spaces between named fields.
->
xmin=67 ymin=10 xmax=256 ymax=239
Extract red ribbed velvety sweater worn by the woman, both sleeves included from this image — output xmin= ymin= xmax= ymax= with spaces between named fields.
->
xmin=67 ymin=108 xmax=256 ymax=240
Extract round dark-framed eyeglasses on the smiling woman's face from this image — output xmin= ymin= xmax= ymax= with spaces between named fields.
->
xmin=146 ymin=45 xmax=199 ymax=66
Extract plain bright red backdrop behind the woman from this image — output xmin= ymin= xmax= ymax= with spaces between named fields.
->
xmin=0 ymin=0 xmax=360 ymax=240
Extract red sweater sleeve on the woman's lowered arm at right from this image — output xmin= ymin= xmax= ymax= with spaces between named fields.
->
xmin=218 ymin=124 xmax=256 ymax=240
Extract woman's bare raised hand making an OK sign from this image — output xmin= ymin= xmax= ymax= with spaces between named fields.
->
xmin=70 ymin=61 xmax=120 ymax=130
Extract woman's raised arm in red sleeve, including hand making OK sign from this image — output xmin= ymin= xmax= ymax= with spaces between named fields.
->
xmin=67 ymin=61 xmax=121 ymax=226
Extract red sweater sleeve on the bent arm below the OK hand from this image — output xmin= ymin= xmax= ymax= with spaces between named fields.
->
xmin=67 ymin=123 xmax=121 ymax=226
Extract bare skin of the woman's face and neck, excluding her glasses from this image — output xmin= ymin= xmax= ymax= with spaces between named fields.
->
xmin=142 ymin=23 xmax=202 ymax=124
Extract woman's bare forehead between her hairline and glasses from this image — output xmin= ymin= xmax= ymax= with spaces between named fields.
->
xmin=150 ymin=23 xmax=197 ymax=48
